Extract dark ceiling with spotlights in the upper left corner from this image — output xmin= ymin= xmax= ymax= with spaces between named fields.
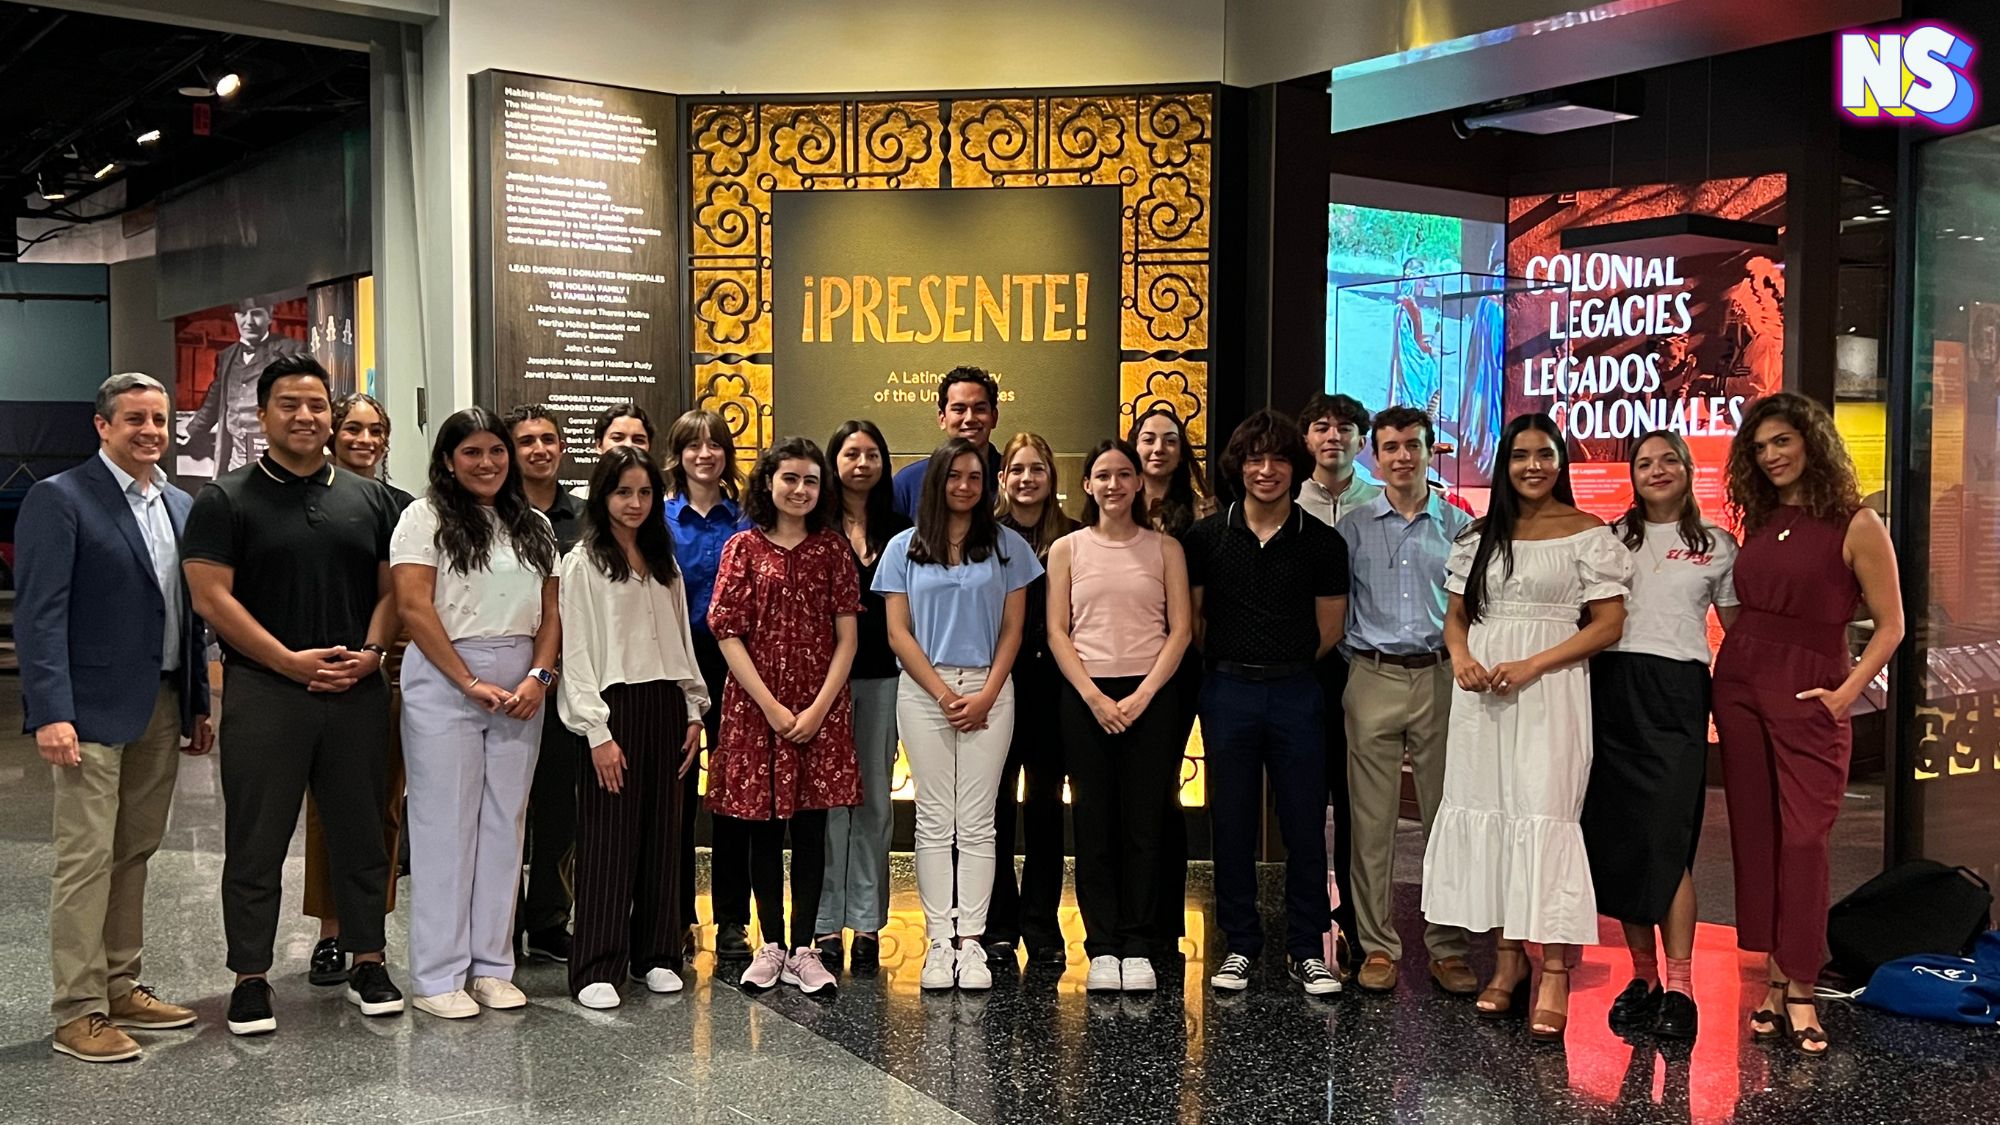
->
xmin=0 ymin=2 xmax=368 ymax=234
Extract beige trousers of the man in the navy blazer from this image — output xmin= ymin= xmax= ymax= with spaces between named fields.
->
xmin=48 ymin=681 xmax=180 ymax=1027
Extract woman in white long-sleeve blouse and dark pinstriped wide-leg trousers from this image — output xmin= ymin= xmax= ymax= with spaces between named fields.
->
xmin=560 ymin=444 xmax=708 ymax=1009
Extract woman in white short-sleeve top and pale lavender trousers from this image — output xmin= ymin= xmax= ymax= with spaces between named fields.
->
xmin=388 ymin=406 xmax=560 ymax=1019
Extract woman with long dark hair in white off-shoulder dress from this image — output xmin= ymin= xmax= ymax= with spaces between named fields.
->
xmin=1424 ymin=414 xmax=1632 ymax=1041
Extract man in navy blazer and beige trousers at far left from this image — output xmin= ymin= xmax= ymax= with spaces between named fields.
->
xmin=14 ymin=374 xmax=214 ymax=1063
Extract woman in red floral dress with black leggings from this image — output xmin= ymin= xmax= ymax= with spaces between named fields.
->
xmin=708 ymin=438 xmax=862 ymax=993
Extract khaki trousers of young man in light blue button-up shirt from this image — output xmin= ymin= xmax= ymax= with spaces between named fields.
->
xmin=1342 ymin=657 xmax=1470 ymax=961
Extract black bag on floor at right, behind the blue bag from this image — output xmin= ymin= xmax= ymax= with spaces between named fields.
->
xmin=1826 ymin=859 xmax=1994 ymax=983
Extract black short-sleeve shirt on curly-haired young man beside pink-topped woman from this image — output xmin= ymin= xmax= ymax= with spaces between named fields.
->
xmin=1180 ymin=502 xmax=1348 ymax=665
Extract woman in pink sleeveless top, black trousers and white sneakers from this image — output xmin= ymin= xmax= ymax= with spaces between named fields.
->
xmin=1048 ymin=440 xmax=1194 ymax=991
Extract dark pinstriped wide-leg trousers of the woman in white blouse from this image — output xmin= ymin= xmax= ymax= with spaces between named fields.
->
xmin=570 ymin=681 xmax=692 ymax=995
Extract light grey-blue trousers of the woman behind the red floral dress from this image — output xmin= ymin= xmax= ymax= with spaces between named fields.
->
xmin=812 ymin=677 xmax=896 ymax=933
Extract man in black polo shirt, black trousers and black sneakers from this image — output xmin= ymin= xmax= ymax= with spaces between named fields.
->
xmin=180 ymin=356 xmax=402 ymax=1035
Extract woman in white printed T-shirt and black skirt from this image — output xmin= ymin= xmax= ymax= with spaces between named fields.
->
xmin=1582 ymin=430 xmax=1736 ymax=1039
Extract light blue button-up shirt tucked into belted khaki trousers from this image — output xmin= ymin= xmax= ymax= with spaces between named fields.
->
xmin=1334 ymin=490 xmax=1472 ymax=657
